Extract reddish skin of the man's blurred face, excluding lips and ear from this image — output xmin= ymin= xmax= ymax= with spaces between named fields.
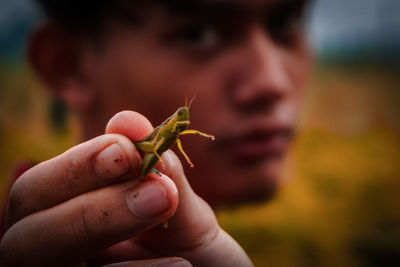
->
xmin=75 ymin=1 xmax=310 ymax=206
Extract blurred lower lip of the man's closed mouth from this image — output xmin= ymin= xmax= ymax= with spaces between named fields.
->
xmin=229 ymin=134 xmax=289 ymax=163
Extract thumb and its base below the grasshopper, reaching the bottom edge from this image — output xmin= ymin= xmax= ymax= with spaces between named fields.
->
xmin=135 ymin=151 xmax=253 ymax=267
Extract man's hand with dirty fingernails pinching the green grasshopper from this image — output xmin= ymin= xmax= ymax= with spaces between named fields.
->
xmin=0 ymin=111 xmax=252 ymax=266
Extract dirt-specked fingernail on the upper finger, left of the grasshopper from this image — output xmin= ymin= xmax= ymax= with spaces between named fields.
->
xmin=93 ymin=143 xmax=130 ymax=179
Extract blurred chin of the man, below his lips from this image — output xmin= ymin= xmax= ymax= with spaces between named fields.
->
xmin=185 ymin=152 xmax=283 ymax=208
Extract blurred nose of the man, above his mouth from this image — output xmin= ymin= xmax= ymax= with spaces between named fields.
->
xmin=230 ymin=25 xmax=291 ymax=112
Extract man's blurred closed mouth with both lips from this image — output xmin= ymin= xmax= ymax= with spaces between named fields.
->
xmin=217 ymin=121 xmax=293 ymax=165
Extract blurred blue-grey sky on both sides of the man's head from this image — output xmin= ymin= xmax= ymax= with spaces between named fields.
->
xmin=0 ymin=0 xmax=400 ymax=58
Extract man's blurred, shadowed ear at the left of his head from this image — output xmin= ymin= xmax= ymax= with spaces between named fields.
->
xmin=27 ymin=22 xmax=94 ymax=111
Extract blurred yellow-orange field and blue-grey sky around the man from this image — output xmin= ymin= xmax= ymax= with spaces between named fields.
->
xmin=0 ymin=0 xmax=400 ymax=266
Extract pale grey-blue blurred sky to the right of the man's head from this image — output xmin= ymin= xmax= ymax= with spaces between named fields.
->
xmin=311 ymin=0 xmax=400 ymax=50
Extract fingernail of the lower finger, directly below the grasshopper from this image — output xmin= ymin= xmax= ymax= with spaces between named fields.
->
xmin=127 ymin=181 xmax=170 ymax=218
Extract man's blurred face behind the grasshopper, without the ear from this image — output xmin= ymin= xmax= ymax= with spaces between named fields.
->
xmin=76 ymin=0 xmax=310 ymax=207
